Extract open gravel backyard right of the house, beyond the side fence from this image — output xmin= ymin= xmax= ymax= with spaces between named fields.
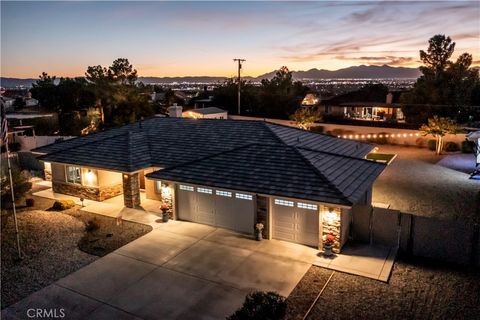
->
xmin=373 ymin=145 xmax=480 ymax=223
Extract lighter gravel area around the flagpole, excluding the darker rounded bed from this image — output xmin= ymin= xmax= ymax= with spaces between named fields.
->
xmin=1 ymin=209 xmax=98 ymax=309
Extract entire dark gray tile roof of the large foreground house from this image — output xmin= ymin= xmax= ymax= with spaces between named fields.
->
xmin=34 ymin=117 xmax=384 ymax=205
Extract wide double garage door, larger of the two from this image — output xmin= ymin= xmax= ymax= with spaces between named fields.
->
xmin=177 ymin=184 xmax=255 ymax=234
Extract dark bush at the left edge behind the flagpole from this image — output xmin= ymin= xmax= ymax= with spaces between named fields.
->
xmin=1 ymin=161 xmax=32 ymax=206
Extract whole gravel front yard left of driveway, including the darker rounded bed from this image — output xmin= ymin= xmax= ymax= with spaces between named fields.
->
xmin=1 ymin=191 xmax=152 ymax=309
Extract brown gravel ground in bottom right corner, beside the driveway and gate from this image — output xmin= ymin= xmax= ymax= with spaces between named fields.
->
xmin=286 ymin=258 xmax=480 ymax=320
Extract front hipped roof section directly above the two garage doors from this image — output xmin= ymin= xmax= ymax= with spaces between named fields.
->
xmin=147 ymin=144 xmax=385 ymax=205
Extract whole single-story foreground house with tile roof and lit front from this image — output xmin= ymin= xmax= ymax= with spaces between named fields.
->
xmin=34 ymin=113 xmax=385 ymax=252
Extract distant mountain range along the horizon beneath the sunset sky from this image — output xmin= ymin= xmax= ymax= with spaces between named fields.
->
xmin=0 ymin=65 xmax=420 ymax=88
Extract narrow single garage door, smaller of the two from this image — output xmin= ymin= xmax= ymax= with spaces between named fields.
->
xmin=273 ymin=199 xmax=318 ymax=247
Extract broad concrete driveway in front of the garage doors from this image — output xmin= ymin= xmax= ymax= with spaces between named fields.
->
xmin=2 ymin=221 xmax=318 ymax=319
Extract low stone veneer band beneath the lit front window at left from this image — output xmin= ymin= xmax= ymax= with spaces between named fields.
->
xmin=52 ymin=181 xmax=123 ymax=201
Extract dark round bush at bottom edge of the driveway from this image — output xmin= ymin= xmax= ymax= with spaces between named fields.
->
xmin=227 ymin=291 xmax=287 ymax=320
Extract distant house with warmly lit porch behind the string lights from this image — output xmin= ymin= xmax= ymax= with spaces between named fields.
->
xmin=322 ymin=92 xmax=405 ymax=121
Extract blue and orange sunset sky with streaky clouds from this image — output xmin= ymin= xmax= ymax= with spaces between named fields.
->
xmin=1 ymin=1 xmax=480 ymax=78
